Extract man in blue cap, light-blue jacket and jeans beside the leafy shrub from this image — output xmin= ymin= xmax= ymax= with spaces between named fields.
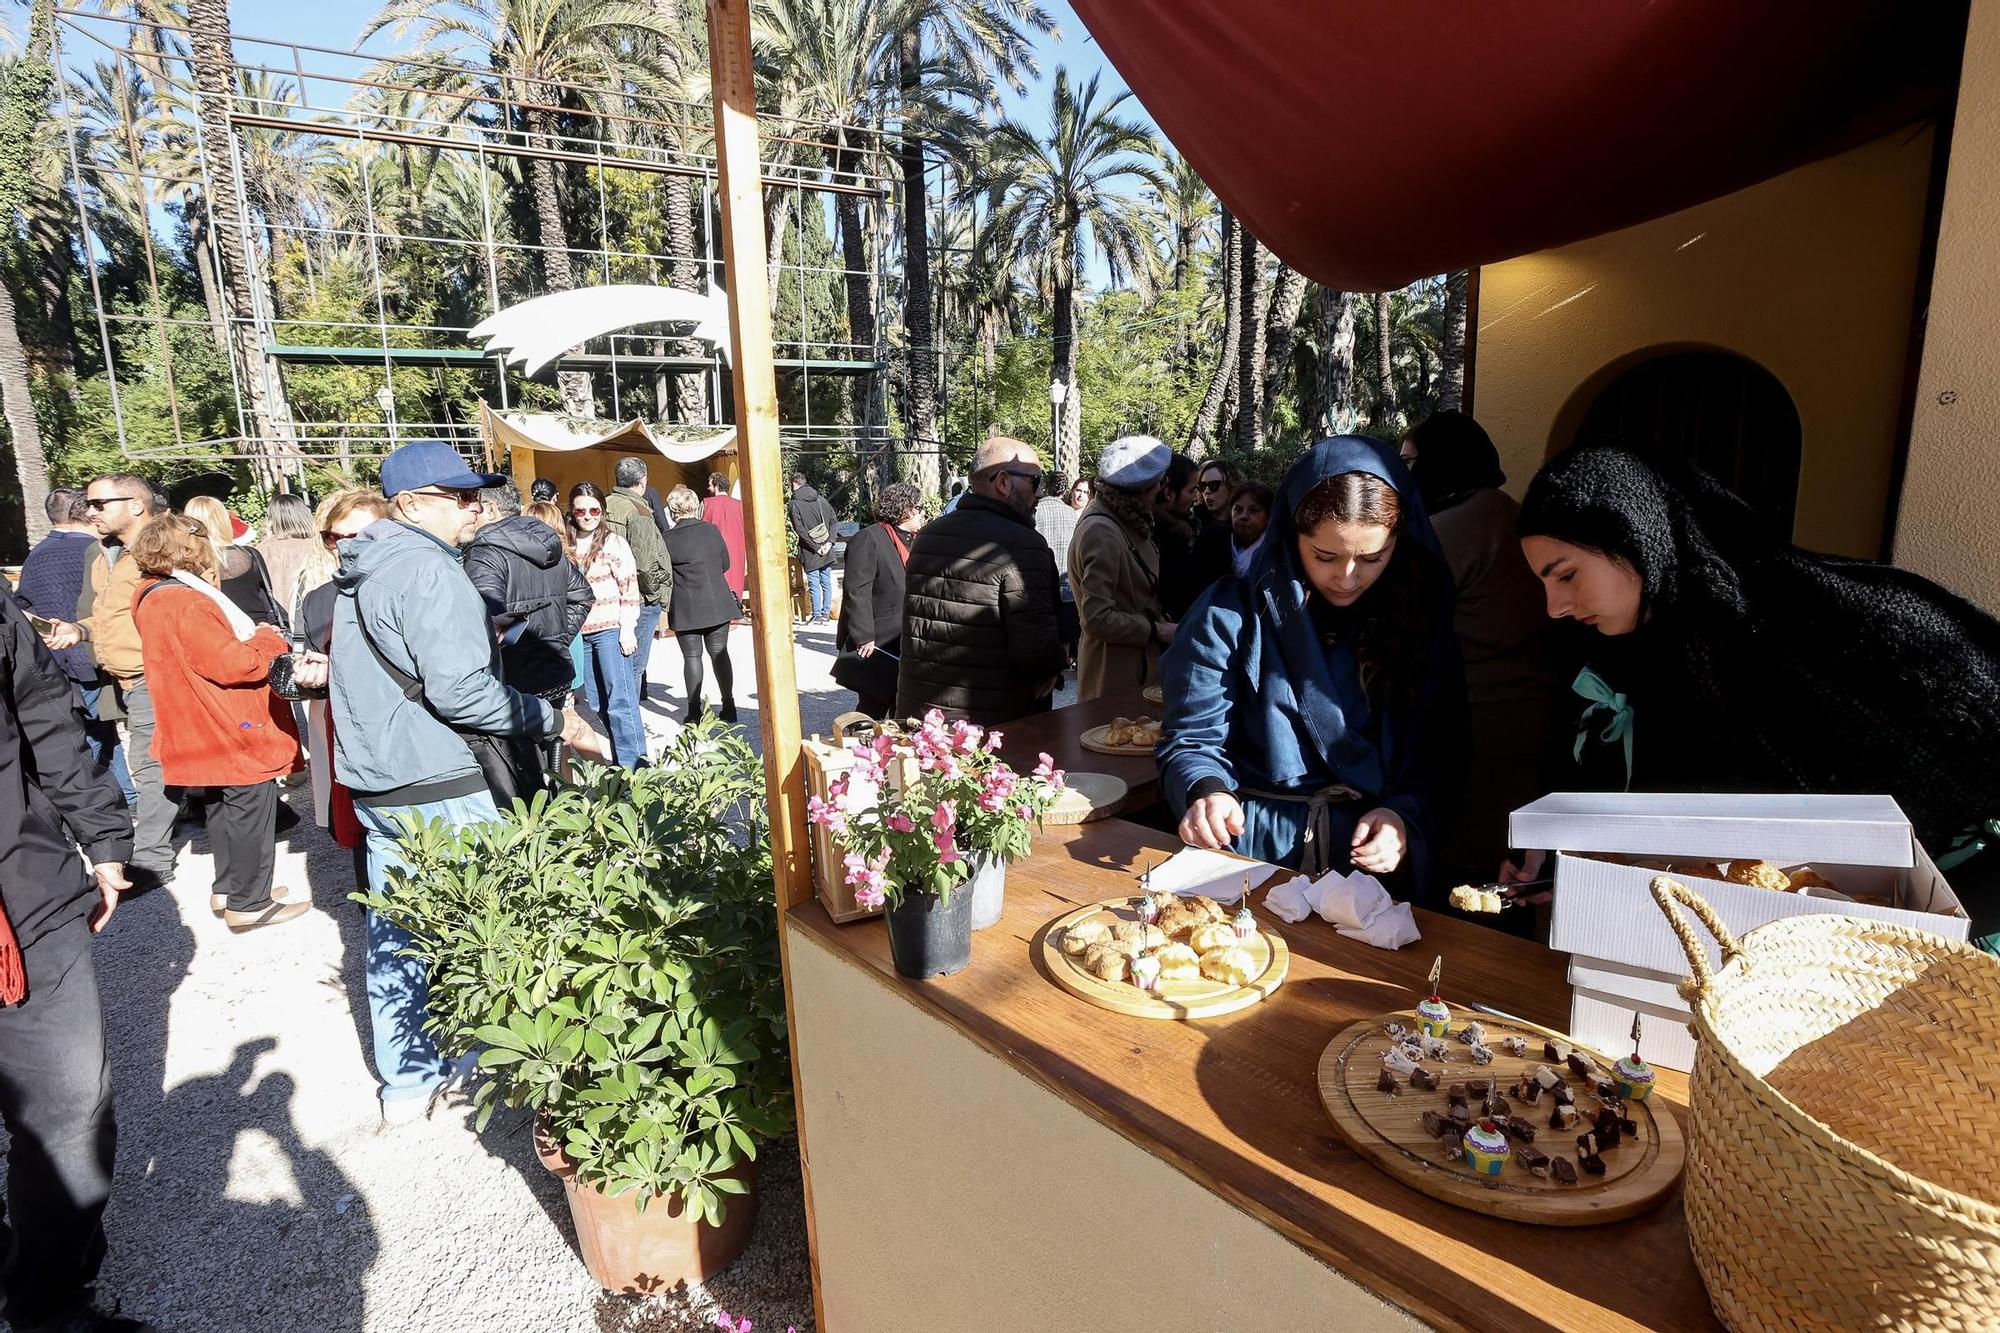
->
xmin=330 ymin=440 xmax=610 ymax=1123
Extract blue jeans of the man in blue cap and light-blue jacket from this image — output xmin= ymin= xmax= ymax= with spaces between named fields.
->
xmin=354 ymin=793 xmax=500 ymax=1103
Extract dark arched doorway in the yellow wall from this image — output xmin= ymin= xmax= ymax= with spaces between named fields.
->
xmin=1552 ymin=348 xmax=1800 ymax=538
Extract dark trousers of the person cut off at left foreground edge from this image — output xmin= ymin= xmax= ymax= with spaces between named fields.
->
xmin=0 ymin=919 xmax=118 ymax=1327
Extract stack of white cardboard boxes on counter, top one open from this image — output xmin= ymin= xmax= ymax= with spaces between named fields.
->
xmin=1508 ymin=793 xmax=1970 ymax=1071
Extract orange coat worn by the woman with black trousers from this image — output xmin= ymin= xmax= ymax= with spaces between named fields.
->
xmin=132 ymin=578 xmax=298 ymax=787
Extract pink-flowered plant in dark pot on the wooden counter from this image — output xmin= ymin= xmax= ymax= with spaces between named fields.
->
xmin=806 ymin=709 xmax=1062 ymax=977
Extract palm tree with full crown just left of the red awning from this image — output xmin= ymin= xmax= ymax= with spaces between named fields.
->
xmin=992 ymin=66 xmax=1162 ymax=476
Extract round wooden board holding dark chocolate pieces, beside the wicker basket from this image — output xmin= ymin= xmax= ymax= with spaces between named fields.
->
xmin=1320 ymin=1009 xmax=1688 ymax=1227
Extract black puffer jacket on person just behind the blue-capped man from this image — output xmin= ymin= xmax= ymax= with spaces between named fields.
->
xmin=466 ymin=514 xmax=592 ymax=695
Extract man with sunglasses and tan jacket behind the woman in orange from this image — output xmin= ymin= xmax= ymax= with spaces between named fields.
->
xmin=44 ymin=472 xmax=180 ymax=891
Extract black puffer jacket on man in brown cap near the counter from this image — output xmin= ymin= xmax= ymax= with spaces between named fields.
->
xmin=896 ymin=494 xmax=1068 ymax=727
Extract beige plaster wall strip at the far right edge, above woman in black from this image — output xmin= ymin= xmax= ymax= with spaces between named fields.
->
xmin=1896 ymin=4 xmax=2000 ymax=610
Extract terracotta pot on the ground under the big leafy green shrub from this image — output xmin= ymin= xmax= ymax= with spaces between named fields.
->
xmin=534 ymin=1123 xmax=756 ymax=1295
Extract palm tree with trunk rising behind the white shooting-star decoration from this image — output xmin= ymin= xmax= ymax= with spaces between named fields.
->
xmin=360 ymin=0 xmax=660 ymax=416
